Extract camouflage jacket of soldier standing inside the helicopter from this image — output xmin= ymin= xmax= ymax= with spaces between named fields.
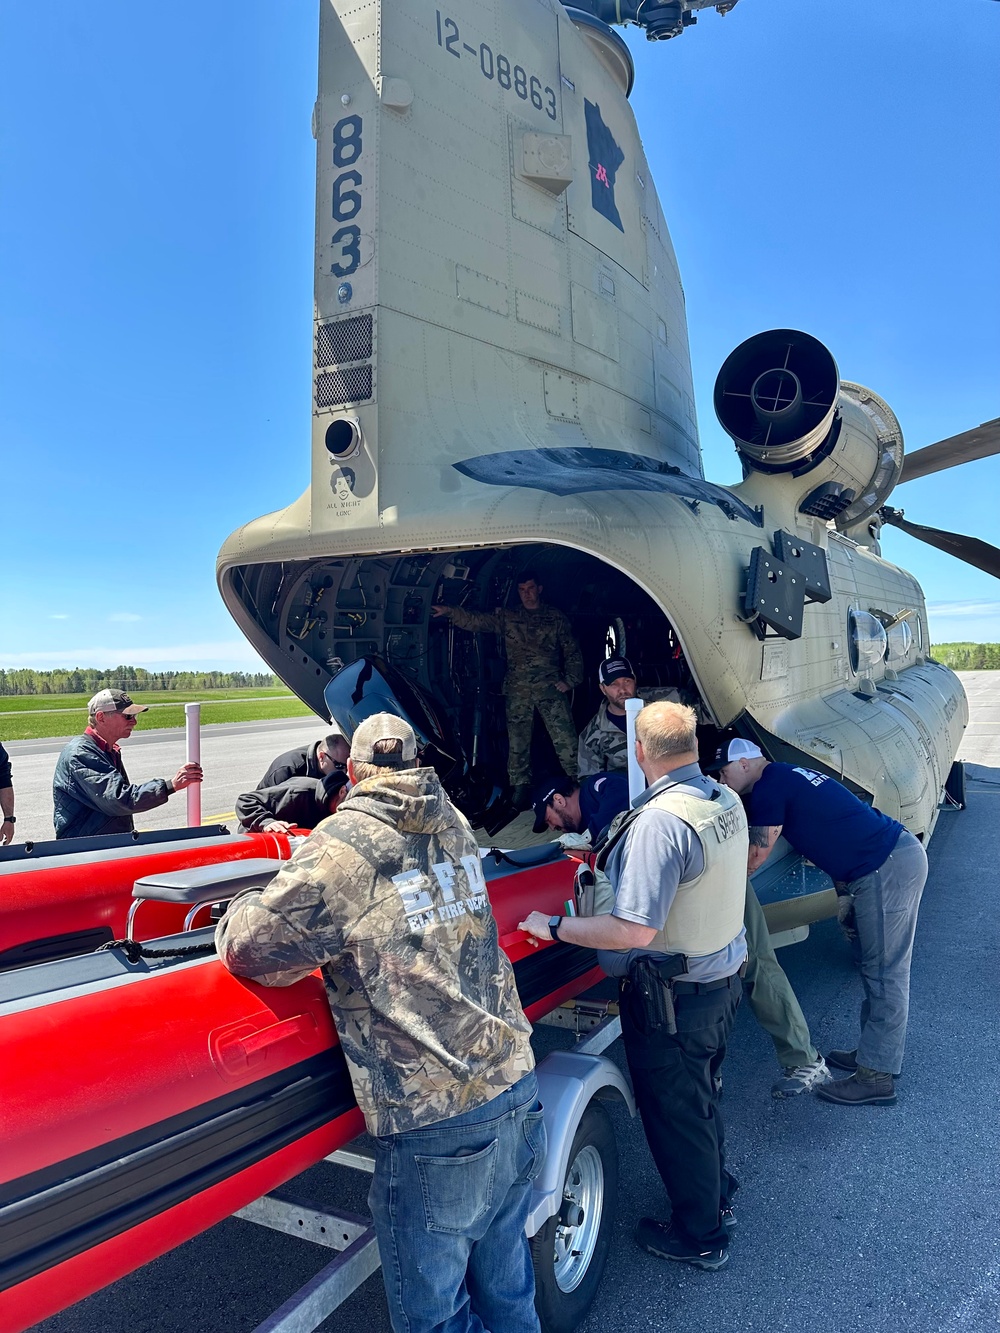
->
xmin=448 ymin=607 xmax=583 ymax=698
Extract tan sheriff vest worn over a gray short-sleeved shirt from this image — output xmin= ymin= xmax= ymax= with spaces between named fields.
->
xmin=600 ymin=786 xmax=749 ymax=958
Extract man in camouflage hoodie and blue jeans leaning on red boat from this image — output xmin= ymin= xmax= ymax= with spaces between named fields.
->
xmin=216 ymin=713 xmax=545 ymax=1333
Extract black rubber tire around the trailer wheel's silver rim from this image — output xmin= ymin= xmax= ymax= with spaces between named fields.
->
xmin=531 ymin=1101 xmax=619 ymax=1333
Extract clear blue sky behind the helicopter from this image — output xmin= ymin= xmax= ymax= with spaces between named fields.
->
xmin=0 ymin=0 xmax=1000 ymax=668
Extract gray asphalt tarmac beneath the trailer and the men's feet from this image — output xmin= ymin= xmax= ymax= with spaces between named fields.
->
xmin=17 ymin=672 xmax=1000 ymax=1333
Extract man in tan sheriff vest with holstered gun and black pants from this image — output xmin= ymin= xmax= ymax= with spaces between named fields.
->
xmin=521 ymin=702 xmax=748 ymax=1270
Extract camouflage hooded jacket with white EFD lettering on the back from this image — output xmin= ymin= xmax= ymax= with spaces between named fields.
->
xmin=216 ymin=768 xmax=535 ymax=1134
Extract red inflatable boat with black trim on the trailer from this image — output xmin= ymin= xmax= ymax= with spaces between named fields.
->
xmin=0 ymin=829 xmax=600 ymax=1333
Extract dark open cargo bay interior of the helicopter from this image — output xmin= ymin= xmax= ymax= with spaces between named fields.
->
xmin=231 ymin=544 xmax=717 ymax=828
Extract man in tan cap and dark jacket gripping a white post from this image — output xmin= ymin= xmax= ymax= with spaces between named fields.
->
xmin=52 ymin=689 xmax=203 ymax=838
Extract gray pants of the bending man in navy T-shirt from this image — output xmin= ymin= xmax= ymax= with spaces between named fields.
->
xmin=848 ymin=829 xmax=927 ymax=1074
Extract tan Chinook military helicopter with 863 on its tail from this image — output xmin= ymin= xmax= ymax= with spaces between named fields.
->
xmin=219 ymin=0 xmax=1000 ymax=921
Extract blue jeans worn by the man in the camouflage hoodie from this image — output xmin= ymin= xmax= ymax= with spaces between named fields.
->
xmin=368 ymin=1073 xmax=545 ymax=1333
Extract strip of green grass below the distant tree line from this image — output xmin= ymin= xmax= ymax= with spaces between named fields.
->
xmin=0 ymin=686 xmax=312 ymax=741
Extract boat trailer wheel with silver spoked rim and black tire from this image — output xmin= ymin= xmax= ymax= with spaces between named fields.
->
xmin=531 ymin=1101 xmax=619 ymax=1333
